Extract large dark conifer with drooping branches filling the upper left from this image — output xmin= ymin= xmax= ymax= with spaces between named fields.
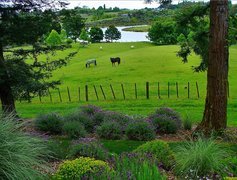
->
xmin=0 ymin=0 xmax=75 ymax=113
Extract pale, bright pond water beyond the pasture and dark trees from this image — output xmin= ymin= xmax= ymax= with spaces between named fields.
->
xmin=102 ymin=26 xmax=149 ymax=42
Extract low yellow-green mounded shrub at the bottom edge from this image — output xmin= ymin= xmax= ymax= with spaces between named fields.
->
xmin=53 ymin=157 xmax=111 ymax=180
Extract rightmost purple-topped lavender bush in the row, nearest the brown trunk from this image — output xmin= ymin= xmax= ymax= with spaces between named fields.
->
xmin=147 ymin=108 xmax=182 ymax=134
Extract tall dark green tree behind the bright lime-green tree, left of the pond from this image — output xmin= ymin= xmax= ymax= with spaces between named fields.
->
xmin=61 ymin=9 xmax=85 ymax=42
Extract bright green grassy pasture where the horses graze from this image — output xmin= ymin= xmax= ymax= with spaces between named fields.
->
xmin=17 ymin=42 xmax=237 ymax=126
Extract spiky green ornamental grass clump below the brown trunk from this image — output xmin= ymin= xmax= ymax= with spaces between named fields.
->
xmin=175 ymin=138 xmax=228 ymax=179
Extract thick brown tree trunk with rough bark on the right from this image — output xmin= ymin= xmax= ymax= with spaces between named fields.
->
xmin=196 ymin=0 xmax=229 ymax=133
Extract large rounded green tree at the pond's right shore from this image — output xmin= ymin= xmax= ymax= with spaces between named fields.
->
xmin=148 ymin=20 xmax=177 ymax=44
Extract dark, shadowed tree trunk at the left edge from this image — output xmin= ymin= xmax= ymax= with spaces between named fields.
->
xmin=0 ymin=44 xmax=16 ymax=114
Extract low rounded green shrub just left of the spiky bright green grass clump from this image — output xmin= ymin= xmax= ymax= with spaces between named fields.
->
xmin=134 ymin=140 xmax=174 ymax=169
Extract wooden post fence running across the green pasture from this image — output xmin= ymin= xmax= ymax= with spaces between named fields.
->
xmin=17 ymin=81 xmax=233 ymax=103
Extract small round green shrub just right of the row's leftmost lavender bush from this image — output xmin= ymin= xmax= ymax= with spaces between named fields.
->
xmin=63 ymin=121 xmax=86 ymax=139
